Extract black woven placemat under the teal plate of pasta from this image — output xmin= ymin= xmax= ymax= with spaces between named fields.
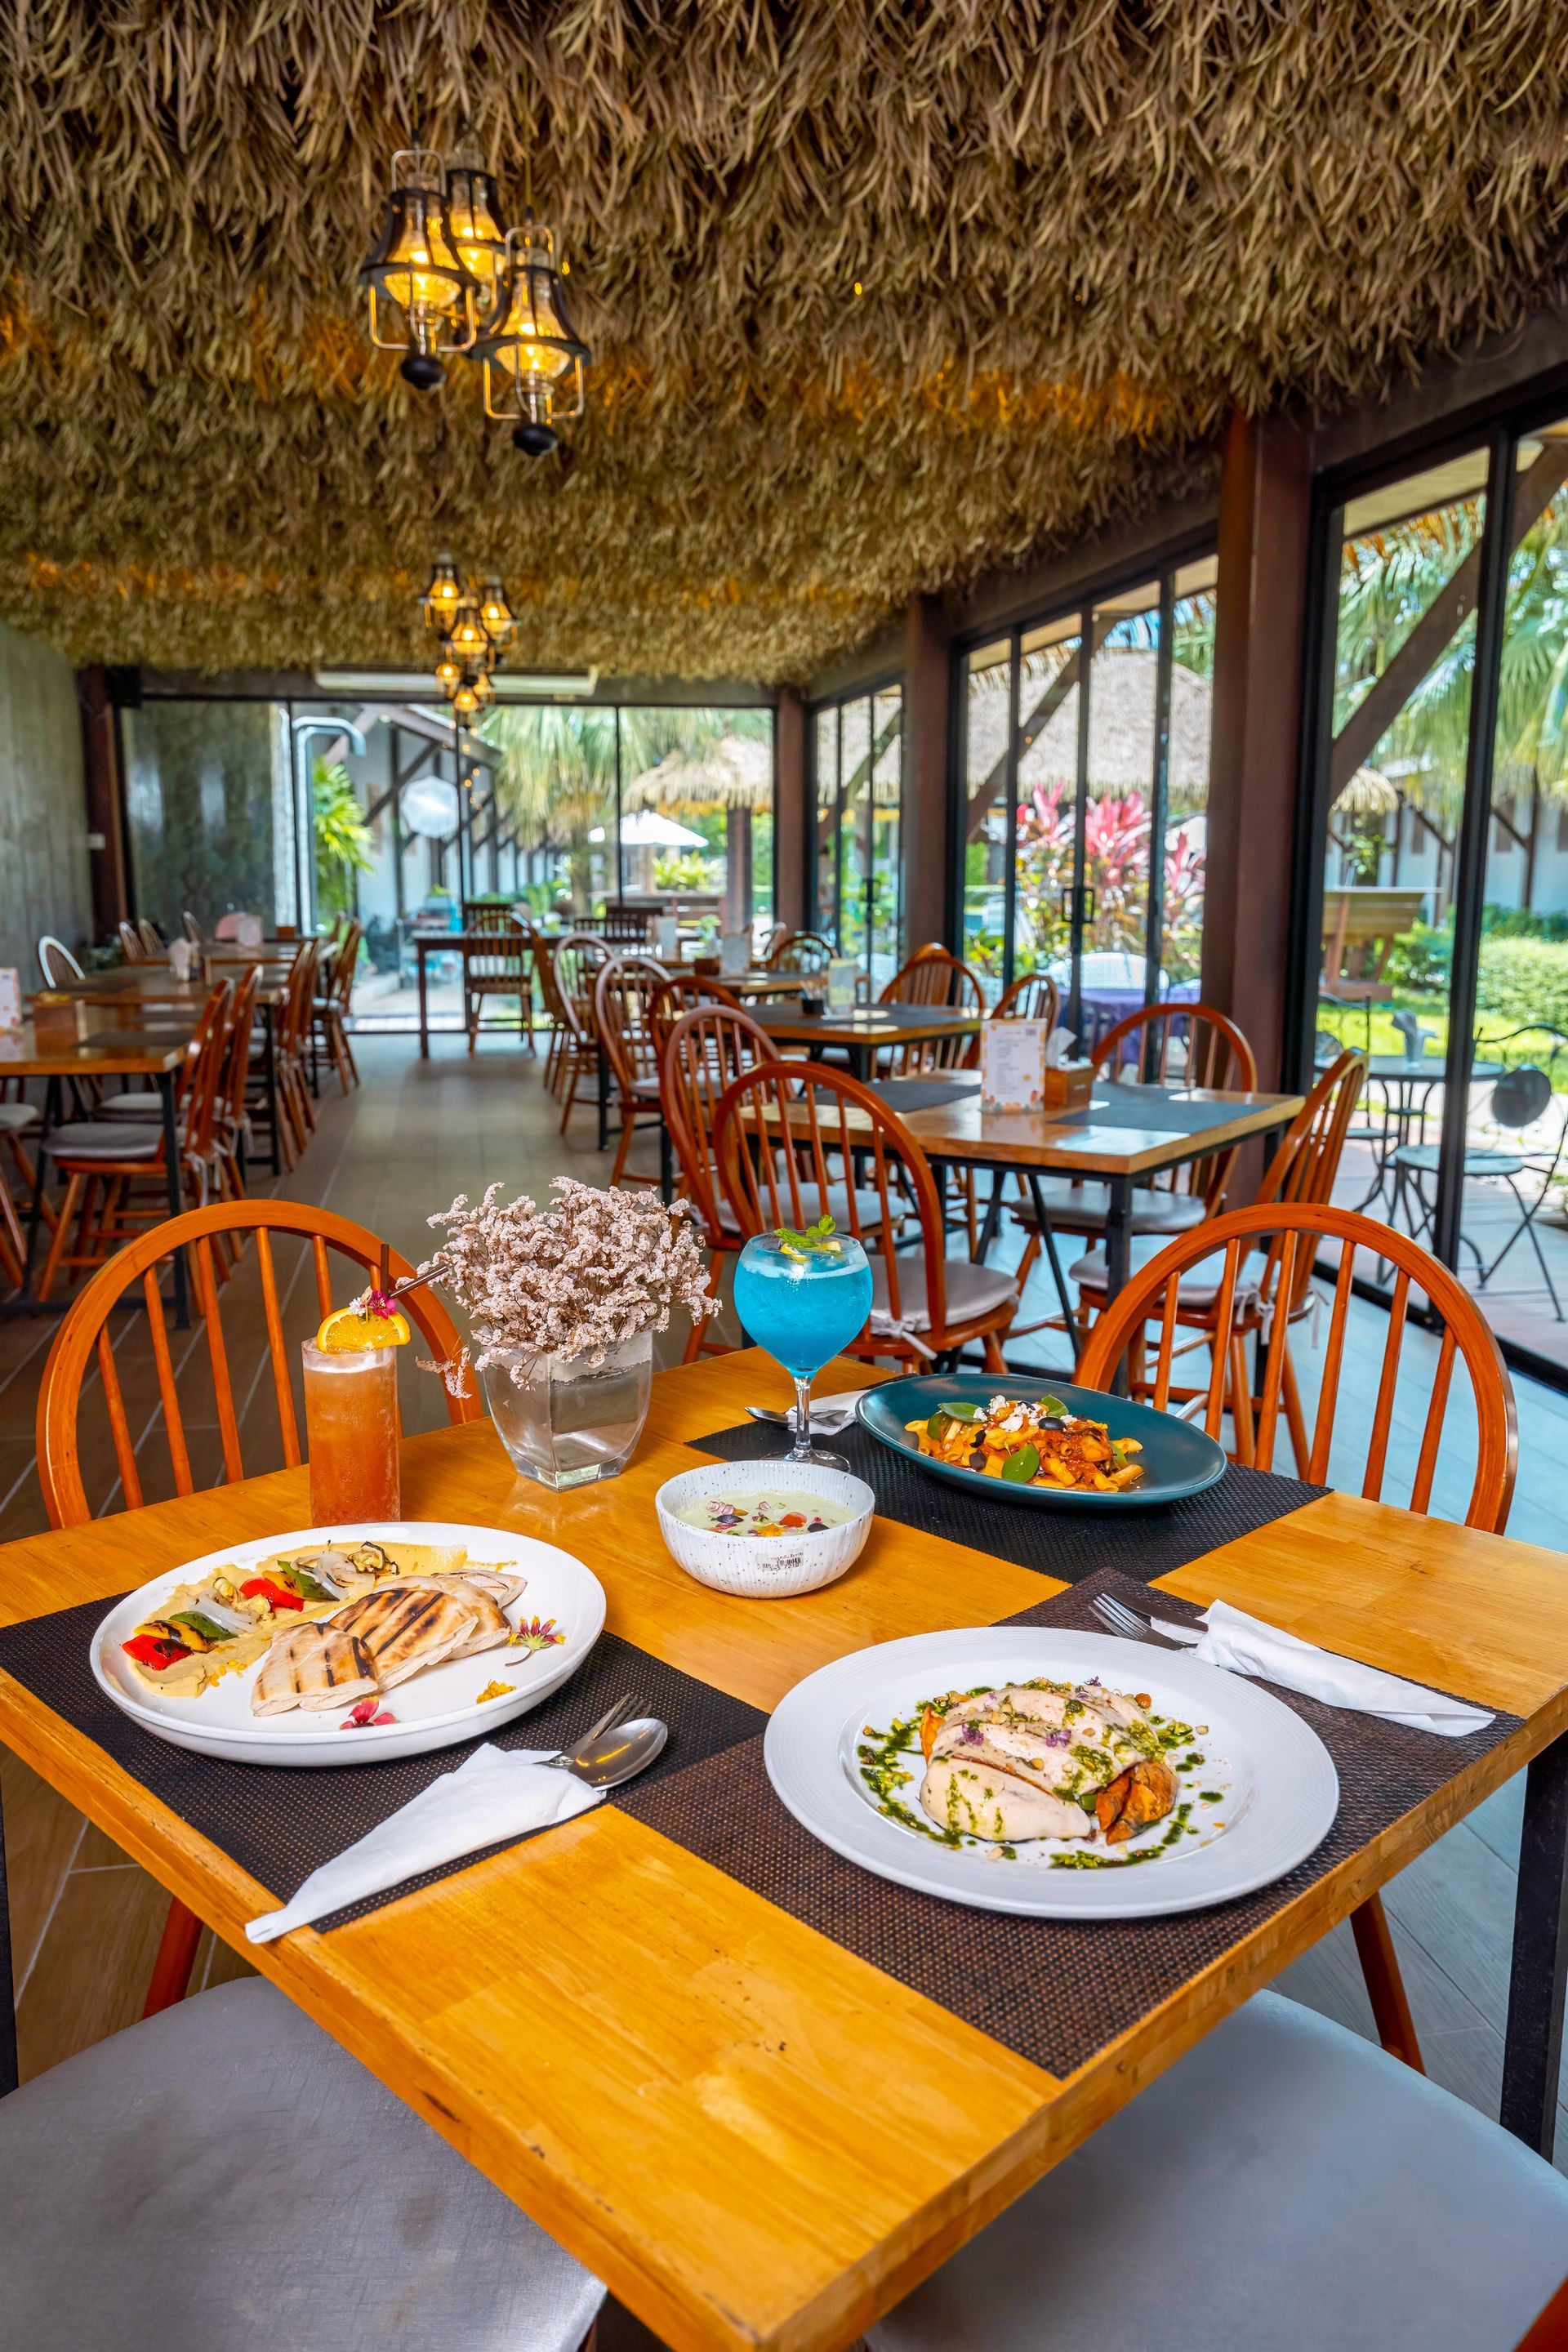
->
xmin=691 ymin=1421 xmax=1328 ymax=1585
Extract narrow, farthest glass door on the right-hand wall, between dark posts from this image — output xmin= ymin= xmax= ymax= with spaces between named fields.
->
xmin=808 ymin=684 xmax=902 ymax=995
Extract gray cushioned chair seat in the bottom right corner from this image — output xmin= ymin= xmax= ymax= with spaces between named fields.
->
xmin=870 ymin=1992 xmax=1568 ymax=2352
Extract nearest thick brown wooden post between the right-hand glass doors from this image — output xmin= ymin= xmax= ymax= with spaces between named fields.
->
xmin=1204 ymin=416 xmax=1312 ymax=1089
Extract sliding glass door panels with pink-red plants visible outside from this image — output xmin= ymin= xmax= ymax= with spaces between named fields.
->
xmin=957 ymin=558 xmax=1215 ymax=1042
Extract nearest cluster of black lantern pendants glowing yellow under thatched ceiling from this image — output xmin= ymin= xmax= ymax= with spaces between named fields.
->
xmin=359 ymin=148 xmax=592 ymax=453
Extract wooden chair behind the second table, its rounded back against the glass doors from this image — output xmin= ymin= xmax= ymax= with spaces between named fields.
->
xmin=1013 ymin=1004 xmax=1258 ymax=1307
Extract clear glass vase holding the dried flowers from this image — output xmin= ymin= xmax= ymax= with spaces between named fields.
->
xmin=479 ymin=1331 xmax=653 ymax=1486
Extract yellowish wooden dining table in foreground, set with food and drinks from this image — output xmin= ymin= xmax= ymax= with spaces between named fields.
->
xmin=0 ymin=1352 xmax=1568 ymax=2352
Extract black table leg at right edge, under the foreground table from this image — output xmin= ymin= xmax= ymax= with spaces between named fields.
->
xmin=1502 ymin=1734 xmax=1568 ymax=2164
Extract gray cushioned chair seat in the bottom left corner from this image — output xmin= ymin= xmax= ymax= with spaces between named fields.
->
xmin=0 ymin=1978 xmax=604 ymax=2352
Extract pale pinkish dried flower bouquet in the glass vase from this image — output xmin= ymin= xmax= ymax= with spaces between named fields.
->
xmin=421 ymin=1176 xmax=719 ymax=1388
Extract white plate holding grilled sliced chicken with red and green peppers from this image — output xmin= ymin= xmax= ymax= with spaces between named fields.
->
xmin=91 ymin=1519 xmax=604 ymax=1764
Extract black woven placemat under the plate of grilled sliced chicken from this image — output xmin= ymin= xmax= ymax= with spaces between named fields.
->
xmin=0 ymin=1601 xmax=764 ymax=1927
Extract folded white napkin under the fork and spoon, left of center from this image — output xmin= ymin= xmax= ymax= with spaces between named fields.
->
xmin=244 ymin=1731 xmax=604 ymax=1943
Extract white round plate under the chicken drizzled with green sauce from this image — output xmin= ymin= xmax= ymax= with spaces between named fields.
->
xmin=764 ymin=1625 xmax=1340 ymax=1919
